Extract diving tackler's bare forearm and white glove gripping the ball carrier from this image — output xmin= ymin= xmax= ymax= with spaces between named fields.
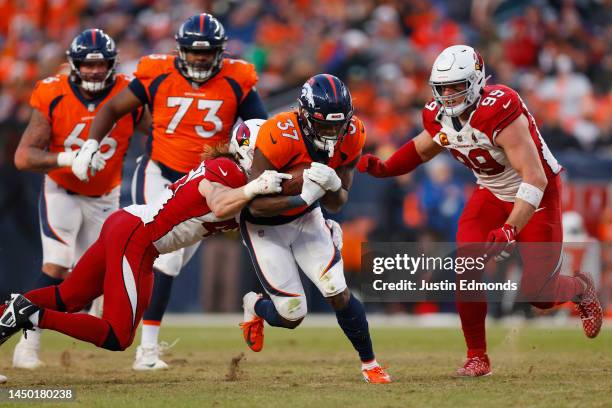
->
xmin=198 ymin=170 xmax=291 ymax=218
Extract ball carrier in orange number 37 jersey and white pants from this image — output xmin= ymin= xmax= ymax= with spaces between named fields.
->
xmin=240 ymin=74 xmax=391 ymax=383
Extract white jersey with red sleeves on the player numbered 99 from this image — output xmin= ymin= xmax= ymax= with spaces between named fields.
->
xmin=423 ymin=85 xmax=561 ymax=202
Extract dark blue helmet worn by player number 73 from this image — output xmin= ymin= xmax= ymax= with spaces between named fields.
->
xmin=174 ymin=13 xmax=227 ymax=82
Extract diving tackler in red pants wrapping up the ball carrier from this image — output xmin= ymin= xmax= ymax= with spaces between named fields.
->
xmin=0 ymin=121 xmax=291 ymax=351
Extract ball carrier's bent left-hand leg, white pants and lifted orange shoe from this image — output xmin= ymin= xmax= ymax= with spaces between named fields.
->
xmin=240 ymin=220 xmax=307 ymax=351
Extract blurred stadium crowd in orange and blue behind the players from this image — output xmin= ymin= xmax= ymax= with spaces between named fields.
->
xmin=0 ymin=0 xmax=612 ymax=318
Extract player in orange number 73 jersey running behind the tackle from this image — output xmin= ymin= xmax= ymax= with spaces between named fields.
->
xmin=78 ymin=14 xmax=267 ymax=370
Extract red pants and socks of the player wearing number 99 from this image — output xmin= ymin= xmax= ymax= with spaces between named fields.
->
xmin=457 ymin=176 xmax=583 ymax=357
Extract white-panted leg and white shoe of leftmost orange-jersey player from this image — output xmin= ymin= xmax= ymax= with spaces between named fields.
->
xmin=13 ymin=176 xmax=82 ymax=369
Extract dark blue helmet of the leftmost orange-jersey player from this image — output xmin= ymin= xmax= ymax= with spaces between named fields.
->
xmin=66 ymin=28 xmax=117 ymax=92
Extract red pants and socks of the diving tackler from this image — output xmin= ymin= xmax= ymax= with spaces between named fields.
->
xmin=24 ymin=211 xmax=159 ymax=351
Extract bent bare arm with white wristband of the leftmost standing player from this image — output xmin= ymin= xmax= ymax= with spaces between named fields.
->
xmin=15 ymin=109 xmax=71 ymax=172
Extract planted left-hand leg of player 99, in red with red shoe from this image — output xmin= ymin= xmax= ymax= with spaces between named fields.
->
xmin=456 ymin=187 xmax=508 ymax=376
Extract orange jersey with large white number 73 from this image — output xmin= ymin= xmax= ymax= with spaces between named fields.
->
xmin=130 ymin=55 xmax=257 ymax=173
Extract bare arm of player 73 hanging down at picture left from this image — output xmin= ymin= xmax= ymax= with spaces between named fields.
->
xmin=88 ymin=88 xmax=144 ymax=142
